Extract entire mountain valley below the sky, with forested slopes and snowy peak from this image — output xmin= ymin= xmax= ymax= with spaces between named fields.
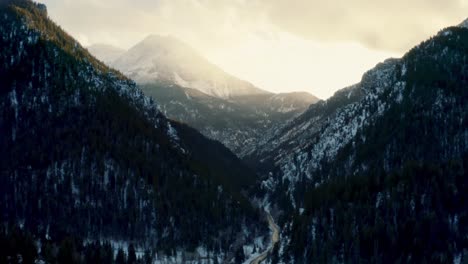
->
xmin=0 ymin=0 xmax=468 ymax=264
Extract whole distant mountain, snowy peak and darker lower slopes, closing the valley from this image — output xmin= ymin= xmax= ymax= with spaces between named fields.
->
xmin=88 ymin=35 xmax=319 ymax=156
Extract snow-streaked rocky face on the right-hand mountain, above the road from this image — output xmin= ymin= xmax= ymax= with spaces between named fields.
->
xmin=243 ymin=59 xmax=398 ymax=173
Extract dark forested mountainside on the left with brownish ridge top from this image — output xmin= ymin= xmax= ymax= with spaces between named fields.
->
xmin=0 ymin=0 xmax=264 ymax=263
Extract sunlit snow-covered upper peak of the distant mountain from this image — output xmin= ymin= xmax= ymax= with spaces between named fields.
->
xmin=112 ymin=35 xmax=267 ymax=99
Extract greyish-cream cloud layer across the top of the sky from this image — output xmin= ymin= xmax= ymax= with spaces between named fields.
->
xmin=45 ymin=0 xmax=468 ymax=52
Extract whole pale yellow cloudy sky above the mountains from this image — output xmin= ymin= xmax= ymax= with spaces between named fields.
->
xmin=39 ymin=0 xmax=468 ymax=98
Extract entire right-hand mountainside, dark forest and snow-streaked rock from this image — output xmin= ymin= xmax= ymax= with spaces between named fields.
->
xmin=250 ymin=24 xmax=468 ymax=263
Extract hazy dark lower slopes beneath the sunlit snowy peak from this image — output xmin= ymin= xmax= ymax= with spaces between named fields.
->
xmin=140 ymin=82 xmax=316 ymax=156
